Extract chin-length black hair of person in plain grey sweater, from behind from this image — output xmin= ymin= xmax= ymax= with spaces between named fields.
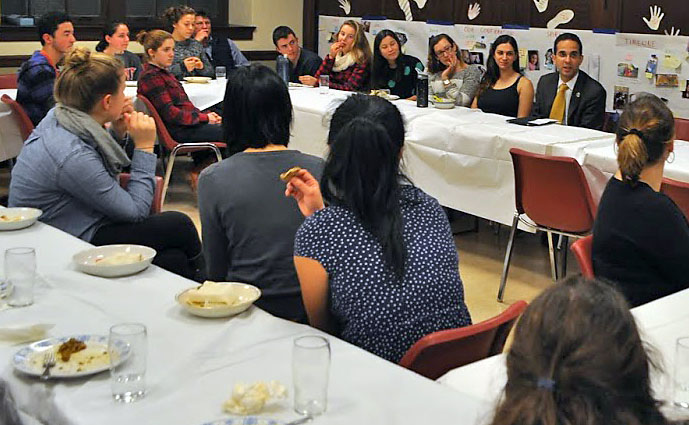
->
xmin=222 ymin=64 xmax=292 ymax=153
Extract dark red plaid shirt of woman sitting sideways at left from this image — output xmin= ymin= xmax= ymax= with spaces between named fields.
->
xmin=137 ymin=63 xmax=208 ymax=127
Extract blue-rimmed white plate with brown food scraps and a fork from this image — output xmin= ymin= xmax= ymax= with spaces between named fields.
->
xmin=12 ymin=335 xmax=130 ymax=378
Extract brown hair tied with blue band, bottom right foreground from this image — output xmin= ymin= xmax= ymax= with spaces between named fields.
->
xmin=492 ymin=276 xmax=668 ymax=425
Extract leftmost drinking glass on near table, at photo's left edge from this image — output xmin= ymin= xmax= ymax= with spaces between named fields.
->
xmin=5 ymin=248 xmax=36 ymax=307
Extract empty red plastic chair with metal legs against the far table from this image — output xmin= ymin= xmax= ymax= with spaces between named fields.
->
xmin=498 ymin=148 xmax=597 ymax=301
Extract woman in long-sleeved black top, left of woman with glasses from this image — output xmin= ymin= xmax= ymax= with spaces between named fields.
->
xmin=371 ymin=30 xmax=424 ymax=100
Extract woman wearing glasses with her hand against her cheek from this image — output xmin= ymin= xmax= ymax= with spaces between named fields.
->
xmin=428 ymin=34 xmax=483 ymax=106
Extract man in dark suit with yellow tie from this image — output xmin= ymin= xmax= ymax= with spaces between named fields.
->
xmin=533 ymin=33 xmax=606 ymax=130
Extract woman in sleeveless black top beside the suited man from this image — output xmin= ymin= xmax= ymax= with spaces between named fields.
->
xmin=471 ymin=35 xmax=534 ymax=118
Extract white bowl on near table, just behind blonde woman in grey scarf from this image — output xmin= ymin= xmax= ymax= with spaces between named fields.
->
xmin=72 ymin=245 xmax=156 ymax=277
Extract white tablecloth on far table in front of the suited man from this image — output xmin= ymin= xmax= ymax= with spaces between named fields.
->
xmin=290 ymin=88 xmax=613 ymax=224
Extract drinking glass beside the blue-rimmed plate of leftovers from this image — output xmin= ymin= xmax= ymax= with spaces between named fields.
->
xmin=108 ymin=323 xmax=148 ymax=403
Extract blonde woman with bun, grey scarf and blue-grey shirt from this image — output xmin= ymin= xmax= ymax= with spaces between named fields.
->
xmin=9 ymin=47 xmax=204 ymax=278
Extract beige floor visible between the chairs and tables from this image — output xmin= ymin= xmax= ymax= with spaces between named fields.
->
xmin=0 ymin=158 xmax=579 ymax=323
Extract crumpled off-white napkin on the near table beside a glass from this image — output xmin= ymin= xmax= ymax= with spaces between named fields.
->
xmin=222 ymin=381 xmax=287 ymax=415
